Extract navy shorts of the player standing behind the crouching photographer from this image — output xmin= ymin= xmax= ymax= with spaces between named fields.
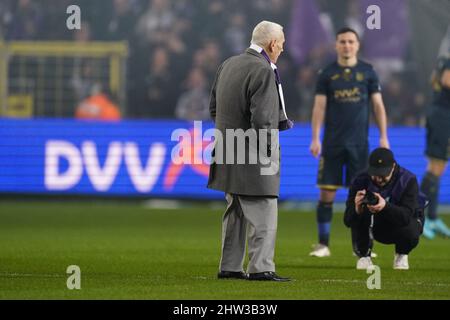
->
xmin=317 ymin=146 xmax=369 ymax=190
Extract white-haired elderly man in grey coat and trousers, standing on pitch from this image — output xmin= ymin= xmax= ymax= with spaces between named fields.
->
xmin=208 ymin=21 xmax=292 ymax=281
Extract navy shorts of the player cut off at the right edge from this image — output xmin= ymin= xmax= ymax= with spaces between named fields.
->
xmin=425 ymin=107 xmax=450 ymax=161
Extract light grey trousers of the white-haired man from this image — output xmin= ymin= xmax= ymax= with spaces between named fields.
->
xmin=220 ymin=193 xmax=278 ymax=273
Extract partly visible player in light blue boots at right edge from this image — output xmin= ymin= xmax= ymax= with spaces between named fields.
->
xmin=420 ymin=57 xmax=450 ymax=239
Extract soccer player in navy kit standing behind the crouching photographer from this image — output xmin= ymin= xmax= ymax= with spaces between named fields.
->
xmin=310 ymin=28 xmax=389 ymax=257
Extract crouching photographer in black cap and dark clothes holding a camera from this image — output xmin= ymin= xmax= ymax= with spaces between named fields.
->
xmin=344 ymin=148 xmax=425 ymax=270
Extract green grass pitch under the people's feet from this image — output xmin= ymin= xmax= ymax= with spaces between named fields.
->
xmin=0 ymin=200 xmax=450 ymax=300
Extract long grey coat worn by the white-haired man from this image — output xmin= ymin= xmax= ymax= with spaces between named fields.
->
xmin=208 ymin=49 xmax=280 ymax=197
